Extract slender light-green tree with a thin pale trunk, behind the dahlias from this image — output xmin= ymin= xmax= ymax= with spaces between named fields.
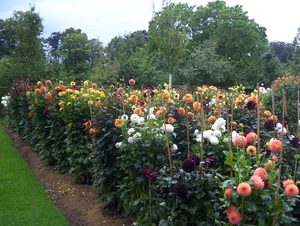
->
xmin=148 ymin=3 xmax=193 ymax=85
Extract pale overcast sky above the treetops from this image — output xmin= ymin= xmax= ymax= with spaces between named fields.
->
xmin=0 ymin=0 xmax=300 ymax=46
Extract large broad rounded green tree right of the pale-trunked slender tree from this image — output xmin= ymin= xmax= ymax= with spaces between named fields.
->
xmin=189 ymin=0 xmax=268 ymax=86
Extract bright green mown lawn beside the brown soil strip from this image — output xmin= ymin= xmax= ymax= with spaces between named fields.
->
xmin=0 ymin=124 xmax=69 ymax=226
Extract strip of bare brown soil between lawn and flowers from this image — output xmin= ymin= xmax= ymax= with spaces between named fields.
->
xmin=2 ymin=123 xmax=132 ymax=226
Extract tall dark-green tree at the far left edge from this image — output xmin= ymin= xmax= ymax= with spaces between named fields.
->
xmin=1 ymin=6 xmax=46 ymax=84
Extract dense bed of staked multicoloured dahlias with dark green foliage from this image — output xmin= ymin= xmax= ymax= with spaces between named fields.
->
xmin=2 ymin=77 xmax=299 ymax=225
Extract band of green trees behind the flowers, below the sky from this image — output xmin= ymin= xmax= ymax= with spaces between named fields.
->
xmin=0 ymin=0 xmax=300 ymax=88
